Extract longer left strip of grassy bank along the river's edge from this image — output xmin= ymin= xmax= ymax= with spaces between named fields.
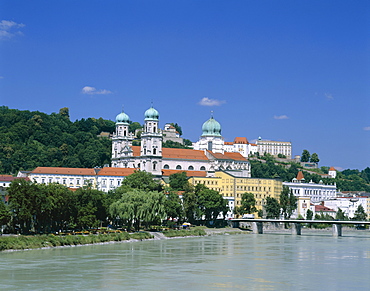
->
xmin=0 ymin=232 xmax=153 ymax=251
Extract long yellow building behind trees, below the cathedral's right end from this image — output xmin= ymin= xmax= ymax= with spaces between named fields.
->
xmin=189 ymin=171 xmax=283 ymax=217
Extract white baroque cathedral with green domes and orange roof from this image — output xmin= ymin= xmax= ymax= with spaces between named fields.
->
xmin=108 ymin=107 xmax=250 ymax=177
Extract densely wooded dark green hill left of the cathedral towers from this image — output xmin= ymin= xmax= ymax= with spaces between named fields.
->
xmin=0 ymin=106 xmax=115 ymax=174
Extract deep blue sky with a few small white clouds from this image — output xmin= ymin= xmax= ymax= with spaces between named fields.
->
xmin=0 ymin=0 xmax=370 ymax=170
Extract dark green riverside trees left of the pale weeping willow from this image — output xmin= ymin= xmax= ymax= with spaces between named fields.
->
xmin=8 ymin=179 xmax=107 ymax=234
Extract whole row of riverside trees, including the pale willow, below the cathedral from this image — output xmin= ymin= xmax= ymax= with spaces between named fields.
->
xmin=0 ymin=171 xmax=229 ymax=234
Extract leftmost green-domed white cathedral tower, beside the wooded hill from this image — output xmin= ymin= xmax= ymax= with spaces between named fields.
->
xmin=112 ymin=110 xmax=133 ymax=168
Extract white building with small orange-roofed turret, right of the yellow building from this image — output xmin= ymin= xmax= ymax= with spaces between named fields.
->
xmin=283 ymin=171 xmax=337 ymax=203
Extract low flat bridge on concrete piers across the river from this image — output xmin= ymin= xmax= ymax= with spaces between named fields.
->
xmin=231 ymin=218 xmax=370 ymax=236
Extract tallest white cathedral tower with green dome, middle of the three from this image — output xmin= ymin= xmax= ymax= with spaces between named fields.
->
xmin=140 ymin=106 xmax=162 ymax=176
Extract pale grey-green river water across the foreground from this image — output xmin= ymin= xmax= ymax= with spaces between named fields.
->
xmin=0 ymin=231 xmax=370 ymax=290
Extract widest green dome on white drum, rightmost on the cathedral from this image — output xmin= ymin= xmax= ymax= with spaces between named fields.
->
xmin=194 ymin=113 xmax=225 ymax=154
